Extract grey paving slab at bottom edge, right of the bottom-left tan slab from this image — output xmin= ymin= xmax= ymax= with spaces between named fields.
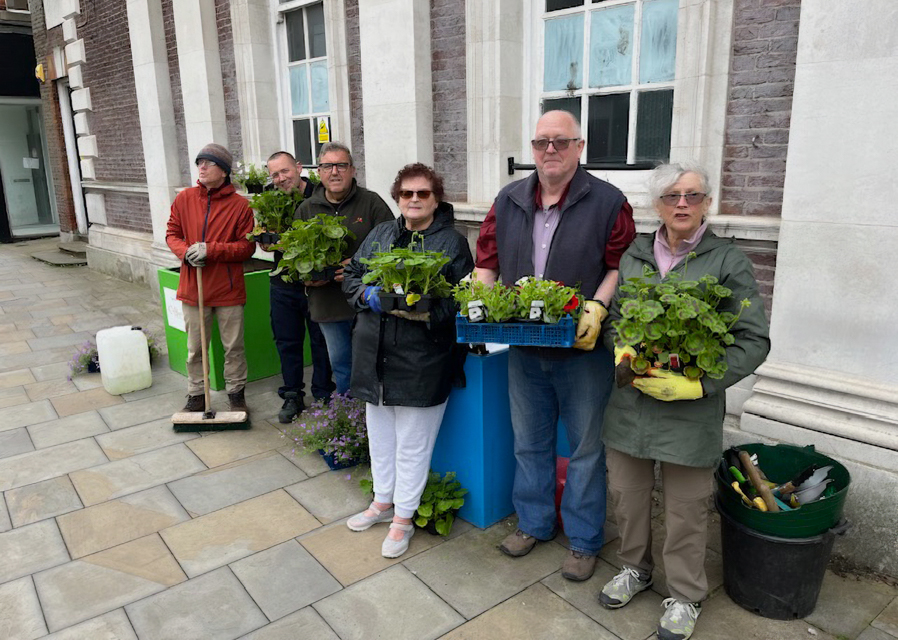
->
xmin=125 ymin=567 xmax=268 ymax=640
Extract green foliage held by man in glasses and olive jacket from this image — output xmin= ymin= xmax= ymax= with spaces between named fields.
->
xmin=271 ymin=213 xmax=355 ymax=282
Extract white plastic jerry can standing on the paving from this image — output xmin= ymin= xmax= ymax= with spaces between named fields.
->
xmin=97 ymin=326 xmax=153 ymax=395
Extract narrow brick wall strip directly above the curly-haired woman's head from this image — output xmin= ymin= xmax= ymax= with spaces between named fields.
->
xmin=430 ymin=0 xmax=468 ymax=202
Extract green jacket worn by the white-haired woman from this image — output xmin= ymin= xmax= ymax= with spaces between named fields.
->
xmin=603 ymin=230 xmax=770 ymax=467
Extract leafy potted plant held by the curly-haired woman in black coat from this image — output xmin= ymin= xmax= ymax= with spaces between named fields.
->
xmin=362 ymin=233 xmax=452 ymax=312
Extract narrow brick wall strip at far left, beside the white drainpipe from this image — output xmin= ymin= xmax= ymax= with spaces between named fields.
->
xmin=30 ymin=0 xmax=78 ymax=233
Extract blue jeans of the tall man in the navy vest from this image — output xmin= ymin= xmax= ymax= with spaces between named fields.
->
xmin=508 ymin=345 xmax=614 ymax=555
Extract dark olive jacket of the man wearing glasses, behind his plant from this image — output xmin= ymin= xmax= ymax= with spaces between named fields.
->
xmin=296 ymin=179 xmax=395 ymax=322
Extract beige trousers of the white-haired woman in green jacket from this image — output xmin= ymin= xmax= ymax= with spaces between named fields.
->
xmin=607 ymin=448 xmax=714 ymax=602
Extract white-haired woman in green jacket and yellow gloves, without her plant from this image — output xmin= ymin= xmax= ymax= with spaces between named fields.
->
xmin=599 ymin=163 xmax=770 ymax=640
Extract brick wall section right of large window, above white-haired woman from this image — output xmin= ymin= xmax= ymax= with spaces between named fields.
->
xmin=720 ymin=0 xmax=801 ymax=216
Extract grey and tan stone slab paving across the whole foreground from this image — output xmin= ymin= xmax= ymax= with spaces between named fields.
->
xmin=0 ymin=241 xmax=898 ymax=640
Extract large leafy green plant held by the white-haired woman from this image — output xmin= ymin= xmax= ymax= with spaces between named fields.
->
xmin=612 ymin=252 xmax=751 ymax=380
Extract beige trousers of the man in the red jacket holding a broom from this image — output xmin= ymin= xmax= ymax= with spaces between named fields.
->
xmin=181 ymin=303 xmax=246 ymax=396
